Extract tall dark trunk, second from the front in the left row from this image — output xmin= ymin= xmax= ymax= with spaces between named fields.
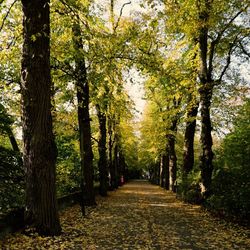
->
xmin=72 ymin=20 xmax=96 ymax=206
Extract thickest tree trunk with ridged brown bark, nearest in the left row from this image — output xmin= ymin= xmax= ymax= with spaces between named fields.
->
xmin=21 ymin=0 xmax=61 ymax=235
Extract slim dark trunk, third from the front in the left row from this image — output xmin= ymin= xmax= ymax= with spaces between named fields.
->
xmin=96 ymin=105 xmax=108 ymax=196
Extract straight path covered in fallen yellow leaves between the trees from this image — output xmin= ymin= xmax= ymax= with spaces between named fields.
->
xmin=0 ymin=181 xmax=250 ymax=250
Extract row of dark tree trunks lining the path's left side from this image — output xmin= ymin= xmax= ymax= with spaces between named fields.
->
xmin=20 ymin=0 xmax=129 ymax=235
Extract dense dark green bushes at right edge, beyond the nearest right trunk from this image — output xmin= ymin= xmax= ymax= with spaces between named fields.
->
xmin=208 ymin=99 xmax=250 ymax=219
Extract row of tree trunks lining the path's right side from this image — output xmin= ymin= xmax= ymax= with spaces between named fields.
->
xmin=158 ymin=0 xmax=214 ymax=199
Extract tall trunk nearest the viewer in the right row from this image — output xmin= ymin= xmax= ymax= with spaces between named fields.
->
xmin=198 ymin=0 xmax=213 ymax=199
